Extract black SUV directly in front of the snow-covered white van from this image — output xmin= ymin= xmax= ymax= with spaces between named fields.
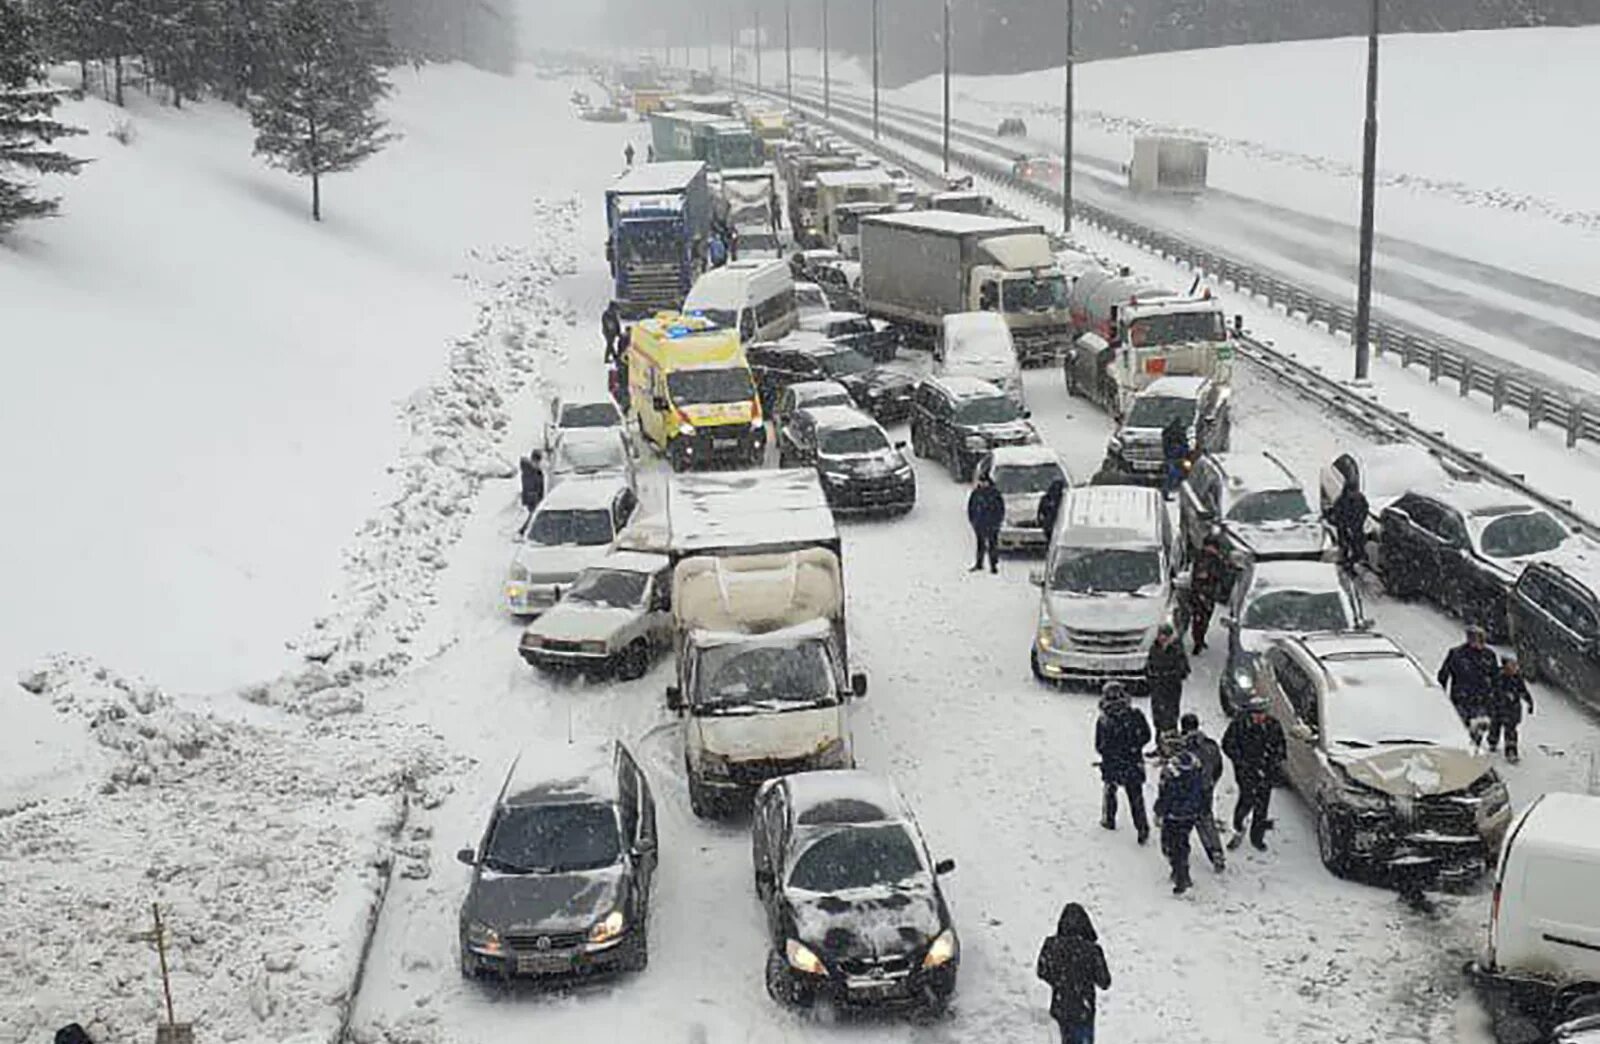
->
xmin=910 ymin=376 xmax=1040 ymax=482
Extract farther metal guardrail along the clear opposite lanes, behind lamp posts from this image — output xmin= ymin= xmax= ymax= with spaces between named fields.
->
xmin=765 ymin=84 xmax=1600 ymax=448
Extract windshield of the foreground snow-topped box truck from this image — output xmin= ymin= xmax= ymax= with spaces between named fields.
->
xmin=694 ymin=640 xmax=838 ymax=714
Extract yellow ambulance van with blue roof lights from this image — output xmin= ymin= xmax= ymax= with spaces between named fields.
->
xmin=627 ymin=312 xmax=766 ymax=471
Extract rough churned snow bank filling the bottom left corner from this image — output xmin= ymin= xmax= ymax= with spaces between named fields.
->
xmin=0 ymin=657 xmax=458 ymax=1041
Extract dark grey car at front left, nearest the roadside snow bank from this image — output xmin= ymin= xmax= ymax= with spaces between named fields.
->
xmin=456 ymin=741 xmax=656 ymax=978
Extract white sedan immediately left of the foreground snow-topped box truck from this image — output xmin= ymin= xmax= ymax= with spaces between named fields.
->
xmin=517 ymin=551 xmax=672 ymax=681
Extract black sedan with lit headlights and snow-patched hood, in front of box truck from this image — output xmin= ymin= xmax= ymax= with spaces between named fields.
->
xmin=750 ymin=770 xmax=962 ymax=1012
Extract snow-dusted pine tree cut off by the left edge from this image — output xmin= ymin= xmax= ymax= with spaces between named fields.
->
xmin=0 ymin=0 xmax=85 ymax=232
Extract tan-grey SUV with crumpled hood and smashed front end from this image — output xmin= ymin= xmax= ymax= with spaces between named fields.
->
xmin=1254 ymin=632 xmax=1512 ymax=882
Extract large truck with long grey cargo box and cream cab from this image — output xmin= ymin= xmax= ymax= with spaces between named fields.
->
xmin=861 ymin=211 xmax=1072 ymax=365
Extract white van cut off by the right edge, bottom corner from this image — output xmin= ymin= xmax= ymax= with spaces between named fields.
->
xmin=1470 ymin=794 xmax=1600 ymax=1022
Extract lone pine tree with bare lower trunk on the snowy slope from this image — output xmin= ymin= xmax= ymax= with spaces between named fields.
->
xmin=251 ymin=0 xmax=395 ymax=221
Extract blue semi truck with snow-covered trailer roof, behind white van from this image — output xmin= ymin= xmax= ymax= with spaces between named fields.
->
xmin=605 ymin=162 xmax=712 ymax=319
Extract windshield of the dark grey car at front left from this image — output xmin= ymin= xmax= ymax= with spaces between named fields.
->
xmin=483 ymin=802 xmax=621 ymax=874
